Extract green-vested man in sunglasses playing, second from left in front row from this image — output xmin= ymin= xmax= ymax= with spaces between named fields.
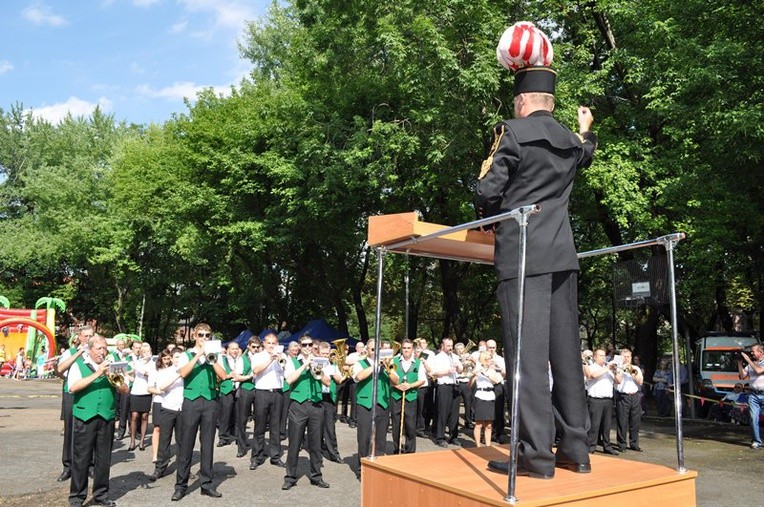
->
xmin=170 ymin=323 xmax=227 ymax=502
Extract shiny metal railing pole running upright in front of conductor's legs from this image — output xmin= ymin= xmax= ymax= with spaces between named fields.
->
xmin=505 ymin=207 xmax=529 ymax=504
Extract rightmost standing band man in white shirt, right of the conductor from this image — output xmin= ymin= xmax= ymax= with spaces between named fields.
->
xmin=615 ymin=349 xmax=645 ymax=452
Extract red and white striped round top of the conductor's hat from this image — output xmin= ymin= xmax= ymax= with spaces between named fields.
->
xmin=496 ymin=21 xmax=554 ymax=71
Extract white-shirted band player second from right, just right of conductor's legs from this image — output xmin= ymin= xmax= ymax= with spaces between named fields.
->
xmin=584 ymin=349 xmax=623 ymax=455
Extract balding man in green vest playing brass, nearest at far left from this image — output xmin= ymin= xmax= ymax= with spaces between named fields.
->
xmin=68 ymin=336 xmax=127 ymax=506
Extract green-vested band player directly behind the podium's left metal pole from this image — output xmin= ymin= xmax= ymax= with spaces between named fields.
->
xmin=353 ymin=339 xmax=397 ymax=463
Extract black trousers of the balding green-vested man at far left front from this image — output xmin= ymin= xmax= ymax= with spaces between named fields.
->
xmin=69 ymin=416 xmax=114 ymax=505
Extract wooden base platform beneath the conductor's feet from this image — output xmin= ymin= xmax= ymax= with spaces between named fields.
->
xmin=361 ymin=446 xmax=698 ymax=507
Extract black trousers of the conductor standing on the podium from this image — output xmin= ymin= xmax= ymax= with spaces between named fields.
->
xmin=497 ymin=271 xmax=589 ymax=474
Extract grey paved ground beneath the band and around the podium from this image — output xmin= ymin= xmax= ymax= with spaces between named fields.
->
xmin=0 ymin=378 xmax=764 ymax=507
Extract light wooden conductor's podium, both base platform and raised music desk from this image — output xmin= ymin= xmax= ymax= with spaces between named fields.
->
xmin=361 ymin=212 xmax=698 ymax=507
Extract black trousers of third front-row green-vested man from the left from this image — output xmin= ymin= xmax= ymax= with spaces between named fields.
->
xmin=284 ymin=401 xmax=324 ymax=483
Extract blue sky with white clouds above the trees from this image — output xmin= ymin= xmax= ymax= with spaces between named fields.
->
xmin=0 ymin=0 xmax=271 ymax=124
